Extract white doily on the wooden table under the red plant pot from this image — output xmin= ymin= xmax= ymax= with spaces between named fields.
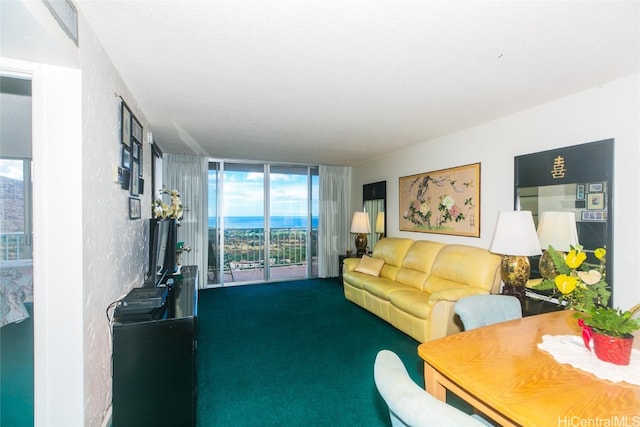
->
xmin=538 ymin=335 xmax=640 ymax=386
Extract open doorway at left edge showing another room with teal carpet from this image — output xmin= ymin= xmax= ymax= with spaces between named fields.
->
xmin=0 ymin=76 xmax=34 ymax=426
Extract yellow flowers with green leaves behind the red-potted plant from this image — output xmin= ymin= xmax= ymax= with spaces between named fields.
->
xmin=536 ymin=245 xmax=611 ymax=311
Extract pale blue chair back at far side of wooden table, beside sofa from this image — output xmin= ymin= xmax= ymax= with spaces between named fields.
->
xmin=454 ymin=295 xmax=522 ymax=331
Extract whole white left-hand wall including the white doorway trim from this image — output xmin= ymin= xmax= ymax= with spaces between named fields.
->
xmin=0 ymin=2 xmax=151 ymax=426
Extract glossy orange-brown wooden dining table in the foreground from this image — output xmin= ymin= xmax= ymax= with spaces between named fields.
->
xmin=418 ymin=310 xmax=640 ymax=427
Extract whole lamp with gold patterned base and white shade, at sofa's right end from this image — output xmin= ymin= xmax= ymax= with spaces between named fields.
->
xmin=489 ymin=211 xmax=542 ymax=302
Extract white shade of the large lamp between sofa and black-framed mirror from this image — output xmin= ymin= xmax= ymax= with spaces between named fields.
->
xmin=489 ymin=211 xmax=542 ymax=256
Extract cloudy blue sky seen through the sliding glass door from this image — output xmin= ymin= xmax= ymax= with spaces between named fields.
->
xmin=209 ymin=172 xmax=318 ymax=217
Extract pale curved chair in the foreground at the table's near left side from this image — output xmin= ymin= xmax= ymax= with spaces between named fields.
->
xmin=373 ymin=350 xmax=492 ymax=427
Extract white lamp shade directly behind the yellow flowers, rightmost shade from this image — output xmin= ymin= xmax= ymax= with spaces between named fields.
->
xmin=538 ymin=212 xmax=578 ymax=252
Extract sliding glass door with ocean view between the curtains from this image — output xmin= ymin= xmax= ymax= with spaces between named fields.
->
xmin=207 ymin=161 xmax=318 ymax=286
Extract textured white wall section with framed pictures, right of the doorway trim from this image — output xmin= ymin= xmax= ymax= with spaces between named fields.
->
xmin=79 ymin=11 xmax=152 ymax=426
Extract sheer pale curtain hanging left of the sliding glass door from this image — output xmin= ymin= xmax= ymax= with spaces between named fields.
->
xmin=162 ymin=154 xmax=208 ymax=288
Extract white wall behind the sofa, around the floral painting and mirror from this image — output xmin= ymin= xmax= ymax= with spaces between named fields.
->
xmin=351 ymin=74 xmax=640 ymax=308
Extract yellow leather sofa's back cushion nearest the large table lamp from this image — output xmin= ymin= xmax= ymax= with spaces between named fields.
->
xmin=424 ymin=245 xmax=501 ymax=293
